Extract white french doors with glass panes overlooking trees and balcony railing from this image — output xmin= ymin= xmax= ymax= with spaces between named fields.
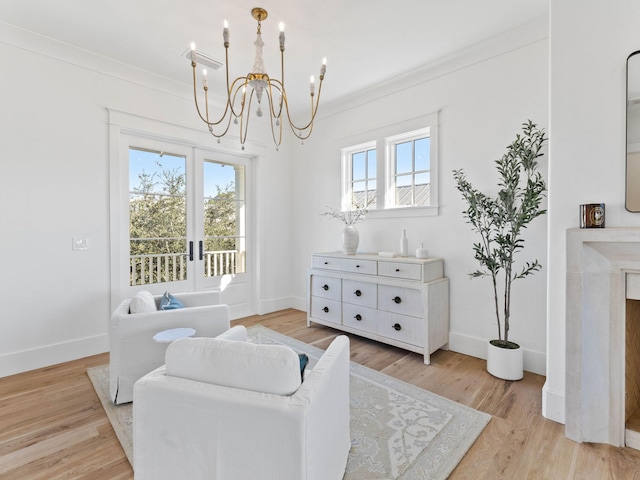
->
xmin=118 ymin=135 xmax=254 ymax=315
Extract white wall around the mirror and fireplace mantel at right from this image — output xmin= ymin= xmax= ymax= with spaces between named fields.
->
xmin=543 ymin=0 xmax=640 ymax=422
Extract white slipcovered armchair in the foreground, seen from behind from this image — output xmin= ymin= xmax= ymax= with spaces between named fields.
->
xmin=133 ymin=327 xmax=351 ymax=480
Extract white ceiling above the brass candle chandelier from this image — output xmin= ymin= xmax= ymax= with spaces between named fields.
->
xmin=0 ymin=0 xmax=548 ymax=109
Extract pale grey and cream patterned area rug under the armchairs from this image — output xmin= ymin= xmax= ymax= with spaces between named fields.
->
xmin=87 ymin=325 xmax=491 ymax=480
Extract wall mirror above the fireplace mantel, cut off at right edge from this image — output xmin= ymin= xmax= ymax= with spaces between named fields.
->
xmin=625 ymin=50 xmax=640 ymax=212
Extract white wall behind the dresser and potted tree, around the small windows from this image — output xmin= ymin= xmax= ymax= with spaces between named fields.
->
xmin=293 ymin=19 xmax=549 ymax=373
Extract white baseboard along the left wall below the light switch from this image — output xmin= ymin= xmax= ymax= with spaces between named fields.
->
xmin=0 ymin=333 xmax=109 ymax=378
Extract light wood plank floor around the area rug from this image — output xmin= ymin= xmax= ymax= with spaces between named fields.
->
xmin=0 ymin=310 xmax=640 ymax=480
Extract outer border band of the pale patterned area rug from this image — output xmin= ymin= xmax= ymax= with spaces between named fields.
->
xmin=87 ymin=325 xmax=491 ymax=480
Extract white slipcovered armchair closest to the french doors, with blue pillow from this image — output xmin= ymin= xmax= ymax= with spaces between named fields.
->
xmin=109 ymin=292 xmax=230 ymax=405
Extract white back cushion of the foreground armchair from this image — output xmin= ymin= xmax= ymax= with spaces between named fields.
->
xmin=165 ymin=338 xmax=301 ymax=395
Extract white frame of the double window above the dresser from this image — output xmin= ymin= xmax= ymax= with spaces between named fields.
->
xmin=340 ymin=112 xmax=439 ymax=218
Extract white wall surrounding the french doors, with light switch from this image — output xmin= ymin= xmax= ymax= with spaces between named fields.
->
xmin=0 ymin=24 xmax=291 ymax=376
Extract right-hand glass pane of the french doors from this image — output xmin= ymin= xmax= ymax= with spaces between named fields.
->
xmin=203 ymin=160 xmax=246 ymax=277
